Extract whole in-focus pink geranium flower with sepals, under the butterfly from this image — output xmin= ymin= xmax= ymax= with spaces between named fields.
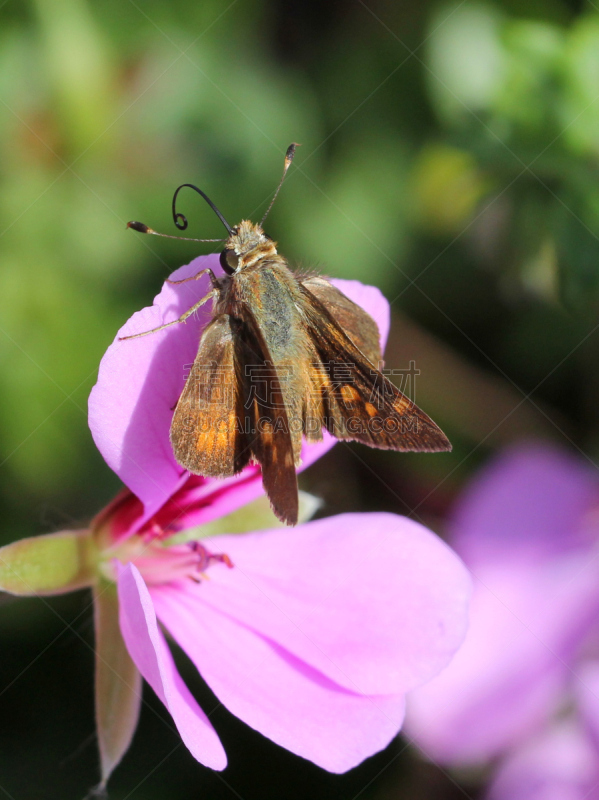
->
xmin=0 ymin=259 xmax=469 ymax=783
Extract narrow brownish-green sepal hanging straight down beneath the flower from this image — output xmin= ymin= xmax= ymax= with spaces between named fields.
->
xmin=93 ymin=581 xmax=142 ymax=787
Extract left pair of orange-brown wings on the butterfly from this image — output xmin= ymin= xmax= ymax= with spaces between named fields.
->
xmin=171 ymin=272 xmax=301 ymax=525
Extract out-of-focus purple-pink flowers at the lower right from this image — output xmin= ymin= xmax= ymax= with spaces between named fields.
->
xmin=406 ymin=445 xmax=599 ymax=800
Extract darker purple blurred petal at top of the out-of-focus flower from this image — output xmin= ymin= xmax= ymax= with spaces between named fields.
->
xmin=452 ymin=444 xmax=599 ymax=567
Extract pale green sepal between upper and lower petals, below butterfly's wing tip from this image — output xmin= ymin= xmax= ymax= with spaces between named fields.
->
xmin=165 ymin=492 xmax=321 ymax=547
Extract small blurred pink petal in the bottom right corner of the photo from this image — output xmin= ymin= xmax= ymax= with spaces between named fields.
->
xmin=487 ymin=720 xmax=599 ymax=800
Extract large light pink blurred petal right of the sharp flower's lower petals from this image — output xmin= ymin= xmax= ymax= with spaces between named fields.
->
xmin=406 ymin=550 xmax=599 ymax=765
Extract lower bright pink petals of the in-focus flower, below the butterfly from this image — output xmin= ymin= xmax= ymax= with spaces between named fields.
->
xmin=109 ymin=490 xmax=468 ymax=772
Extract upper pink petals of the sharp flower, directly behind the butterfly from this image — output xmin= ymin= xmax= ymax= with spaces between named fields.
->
xmin=89 ymin=255 xmax=389 ymax=521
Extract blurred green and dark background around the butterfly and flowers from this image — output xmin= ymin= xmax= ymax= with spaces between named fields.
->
xmin=0 ymin=0 xmax=599 ymax=800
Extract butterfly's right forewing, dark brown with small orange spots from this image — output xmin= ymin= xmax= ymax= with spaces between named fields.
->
xmin=301 ymin=282 xmax=451 ymax=452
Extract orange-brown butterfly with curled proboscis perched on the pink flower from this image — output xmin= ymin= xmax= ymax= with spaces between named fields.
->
xmin=124 ymin=144 xmax=451 ymax=525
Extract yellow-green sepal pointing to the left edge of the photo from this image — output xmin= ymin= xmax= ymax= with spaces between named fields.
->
xmin=0 ymin=530 xmax=95 ymax=595
